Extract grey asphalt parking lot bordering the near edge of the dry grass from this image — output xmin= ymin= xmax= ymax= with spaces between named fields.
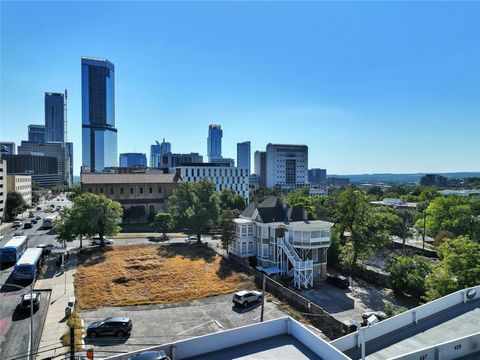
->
xmin=80 ymin=294 xmax=286 ymax=357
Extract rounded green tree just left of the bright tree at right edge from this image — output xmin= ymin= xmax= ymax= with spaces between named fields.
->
xmin=387 ymin=256 xmax=432 ymax=299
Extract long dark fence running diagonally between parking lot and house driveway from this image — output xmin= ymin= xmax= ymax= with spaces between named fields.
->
xmin=224 ymin=254 xmax=349 ymax=340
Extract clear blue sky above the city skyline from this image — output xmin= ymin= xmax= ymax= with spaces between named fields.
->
xmin=0 ymin=2 xmax=480 ymax=174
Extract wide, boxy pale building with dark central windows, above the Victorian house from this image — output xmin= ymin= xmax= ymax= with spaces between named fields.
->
xmin=267 ymin=144 xmax=308 ymax=189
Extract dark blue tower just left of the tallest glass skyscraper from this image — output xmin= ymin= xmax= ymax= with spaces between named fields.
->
xmin=44 ymin=92 xmax=67 ymax=143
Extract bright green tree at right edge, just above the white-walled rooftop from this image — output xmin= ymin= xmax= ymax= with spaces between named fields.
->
xmin=425 ymin=236 xmax=480 ymax=301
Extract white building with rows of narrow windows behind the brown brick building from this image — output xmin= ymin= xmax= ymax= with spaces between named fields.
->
xmin=171 ymin=163 xmax=249 ymax=201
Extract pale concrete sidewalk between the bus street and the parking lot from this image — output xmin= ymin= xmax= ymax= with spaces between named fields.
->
xmin=35 ymin=249 xmax=77 ymax=359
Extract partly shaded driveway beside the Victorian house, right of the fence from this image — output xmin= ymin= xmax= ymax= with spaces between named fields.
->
xmin=300 ymin=279 xmax=415 ymax=322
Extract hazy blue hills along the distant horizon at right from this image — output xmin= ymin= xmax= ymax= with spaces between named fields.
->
xmin=328 ymin=172 xmax=480 ymax=184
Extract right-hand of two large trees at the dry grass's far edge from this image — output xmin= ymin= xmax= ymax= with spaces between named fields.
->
xmin=168 ymin=179 xmax=220 ymax=243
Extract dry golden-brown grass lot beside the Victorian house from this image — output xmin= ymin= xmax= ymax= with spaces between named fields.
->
xmin=75 ymin=244 xmax=254 ymax=309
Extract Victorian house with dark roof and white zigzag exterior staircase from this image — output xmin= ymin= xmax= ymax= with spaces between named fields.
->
xmin=229 ymin=196 xmax=333 ymax=288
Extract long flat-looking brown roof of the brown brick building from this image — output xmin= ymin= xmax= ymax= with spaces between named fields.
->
xmin=80 ymin=173 xmax=181 ymax=184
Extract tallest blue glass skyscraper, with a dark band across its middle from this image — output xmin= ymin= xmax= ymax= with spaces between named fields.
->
xmin=82 ymin=57 xmax=118 ymax=172
